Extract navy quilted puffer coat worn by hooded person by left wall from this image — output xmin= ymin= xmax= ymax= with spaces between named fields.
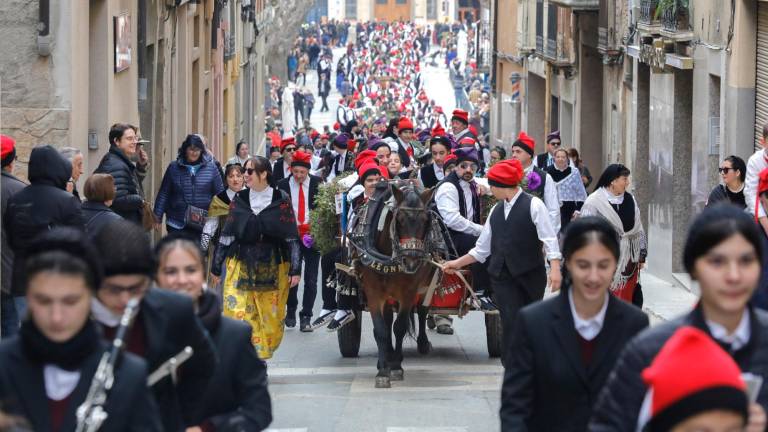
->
xmin=155 ymin=153 xmax=224 ymax=228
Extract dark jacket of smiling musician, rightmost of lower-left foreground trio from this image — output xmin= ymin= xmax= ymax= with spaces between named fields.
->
xmin=202 ymin=308 xmax=272 ymax=432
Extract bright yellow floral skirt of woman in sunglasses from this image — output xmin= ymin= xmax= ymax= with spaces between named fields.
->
xmin=223 ymin=258 xmax=290 ymax=360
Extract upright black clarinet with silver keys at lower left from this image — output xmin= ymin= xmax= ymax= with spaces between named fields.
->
xmin=75 ymin=298 xmax=139 ymax=432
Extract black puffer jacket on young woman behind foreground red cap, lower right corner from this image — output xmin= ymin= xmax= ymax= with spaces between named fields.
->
xmin=588 ymin=307 xmax=768 ymax=432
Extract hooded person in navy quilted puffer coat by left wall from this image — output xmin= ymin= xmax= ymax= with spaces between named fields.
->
xmin=155 ymin=135 xmax=224 ymax=238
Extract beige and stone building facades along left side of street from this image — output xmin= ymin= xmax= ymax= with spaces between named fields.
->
xmin=0 ymin=0 xmax=272 ymax=202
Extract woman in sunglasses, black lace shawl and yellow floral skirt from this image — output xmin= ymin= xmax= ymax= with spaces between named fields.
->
xmin=211 ymin=156 xmax=301 ymax=359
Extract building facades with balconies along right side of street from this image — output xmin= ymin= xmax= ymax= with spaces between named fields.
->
xmin=491 ymin=0 xmax=768 ymax=284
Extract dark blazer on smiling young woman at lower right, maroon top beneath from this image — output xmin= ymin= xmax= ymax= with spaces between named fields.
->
xmin=501 ymin=290 xmax=648 ymax=431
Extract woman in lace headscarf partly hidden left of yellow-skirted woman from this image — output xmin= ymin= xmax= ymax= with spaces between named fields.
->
xmin=200 ymin=164 xmax=245 ymax=297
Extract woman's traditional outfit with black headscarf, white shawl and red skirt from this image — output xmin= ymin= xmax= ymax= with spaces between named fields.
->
xmin=581 ymin=164 xmax=647 ymax=303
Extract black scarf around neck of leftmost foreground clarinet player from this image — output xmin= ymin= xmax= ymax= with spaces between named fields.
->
xmin=19 ymin=319 xmax=100 ymax=371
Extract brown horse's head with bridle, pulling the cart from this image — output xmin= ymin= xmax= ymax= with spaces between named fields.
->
xmin=390 ymin=181 xmax=432 ymax=274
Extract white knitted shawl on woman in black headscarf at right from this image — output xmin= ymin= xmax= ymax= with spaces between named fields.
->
xmin=582 ymin=188 xmax=645 ymax=289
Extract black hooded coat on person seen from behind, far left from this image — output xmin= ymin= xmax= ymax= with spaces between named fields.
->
xmin=3 ymin=146 xmax=83 ymax=295
